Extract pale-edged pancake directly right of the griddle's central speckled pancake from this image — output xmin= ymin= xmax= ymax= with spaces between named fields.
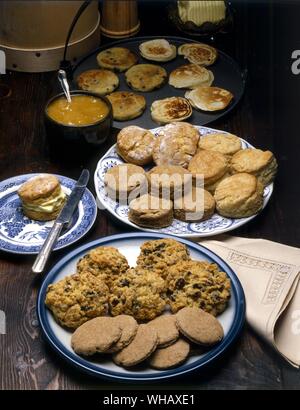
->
xmin=169 ymin=64 xmax=214 ymax=88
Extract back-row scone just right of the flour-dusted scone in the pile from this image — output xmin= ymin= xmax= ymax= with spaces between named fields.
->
xmin=199 ymin=132 xmax=242 ymax=159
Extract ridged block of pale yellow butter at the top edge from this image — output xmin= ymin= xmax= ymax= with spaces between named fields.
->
xmin=177 ymin=0 xmax=226 ymax=26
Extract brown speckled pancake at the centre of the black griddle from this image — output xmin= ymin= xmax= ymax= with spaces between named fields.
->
xmin=125 ymin=64 xmax=168 ymax=92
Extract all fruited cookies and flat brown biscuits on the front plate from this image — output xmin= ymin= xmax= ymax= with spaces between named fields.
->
xmin=45 ymin=239 xmax=231 ymax=368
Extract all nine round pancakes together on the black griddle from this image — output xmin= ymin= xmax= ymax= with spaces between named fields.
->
xmin=77 ymin=39 xmax=233 ymax=124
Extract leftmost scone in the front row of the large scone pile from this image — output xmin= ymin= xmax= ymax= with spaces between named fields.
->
xmin=128 ymin=194 xmax=173 ymax=229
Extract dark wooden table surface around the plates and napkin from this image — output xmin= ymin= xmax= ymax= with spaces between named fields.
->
xmin=0 ymin=2 xmax=300 ymax=390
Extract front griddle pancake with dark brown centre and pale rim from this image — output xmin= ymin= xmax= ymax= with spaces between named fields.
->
xmin=151 ymin=97 xmax=193 ymax=124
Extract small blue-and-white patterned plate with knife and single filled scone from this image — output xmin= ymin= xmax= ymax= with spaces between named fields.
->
xmin=0 ymin=174 xmax=97 ymax=254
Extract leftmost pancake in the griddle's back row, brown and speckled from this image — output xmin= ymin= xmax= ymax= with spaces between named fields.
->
xmin=97 ymin=47 xmax=138 ymax=72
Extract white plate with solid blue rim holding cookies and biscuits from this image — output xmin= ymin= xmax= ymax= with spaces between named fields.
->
xmin=37 ymin=232 xmax=245 ymax=382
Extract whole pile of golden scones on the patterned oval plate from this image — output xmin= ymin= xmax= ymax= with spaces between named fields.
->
xmin=104 ymin=122 xmax=277 ymax=229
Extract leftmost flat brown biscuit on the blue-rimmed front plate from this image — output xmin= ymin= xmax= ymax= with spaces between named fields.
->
xmin=71 ymin=317 xmax=122 ymax=356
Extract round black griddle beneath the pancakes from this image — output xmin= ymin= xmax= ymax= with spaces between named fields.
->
xmin=73 ymin=36 xmax=245 ymax=129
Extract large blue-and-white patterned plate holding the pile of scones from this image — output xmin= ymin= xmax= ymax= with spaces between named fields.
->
xmin=94 ymin=126 xmax=273 ymax=238
